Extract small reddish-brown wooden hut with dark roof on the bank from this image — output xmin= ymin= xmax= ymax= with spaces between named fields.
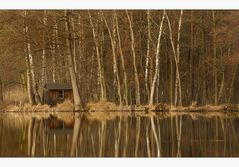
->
xmin=43 ymin=83 xmax=73 ymax=106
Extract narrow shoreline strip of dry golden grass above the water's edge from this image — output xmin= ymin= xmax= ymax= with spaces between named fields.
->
xmin=0 ymin=103 xmax=239 ymax=113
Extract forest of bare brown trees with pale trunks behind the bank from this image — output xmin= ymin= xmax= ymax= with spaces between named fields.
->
xmin=0 ymin=10 xmax=239 ymax=106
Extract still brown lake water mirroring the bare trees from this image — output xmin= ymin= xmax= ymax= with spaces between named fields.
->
xmin=0 ymin=112 xmax=239 ymax=157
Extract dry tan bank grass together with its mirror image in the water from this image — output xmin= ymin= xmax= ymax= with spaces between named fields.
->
xmin=0 ymin=97 xmax=239 ymax=122
